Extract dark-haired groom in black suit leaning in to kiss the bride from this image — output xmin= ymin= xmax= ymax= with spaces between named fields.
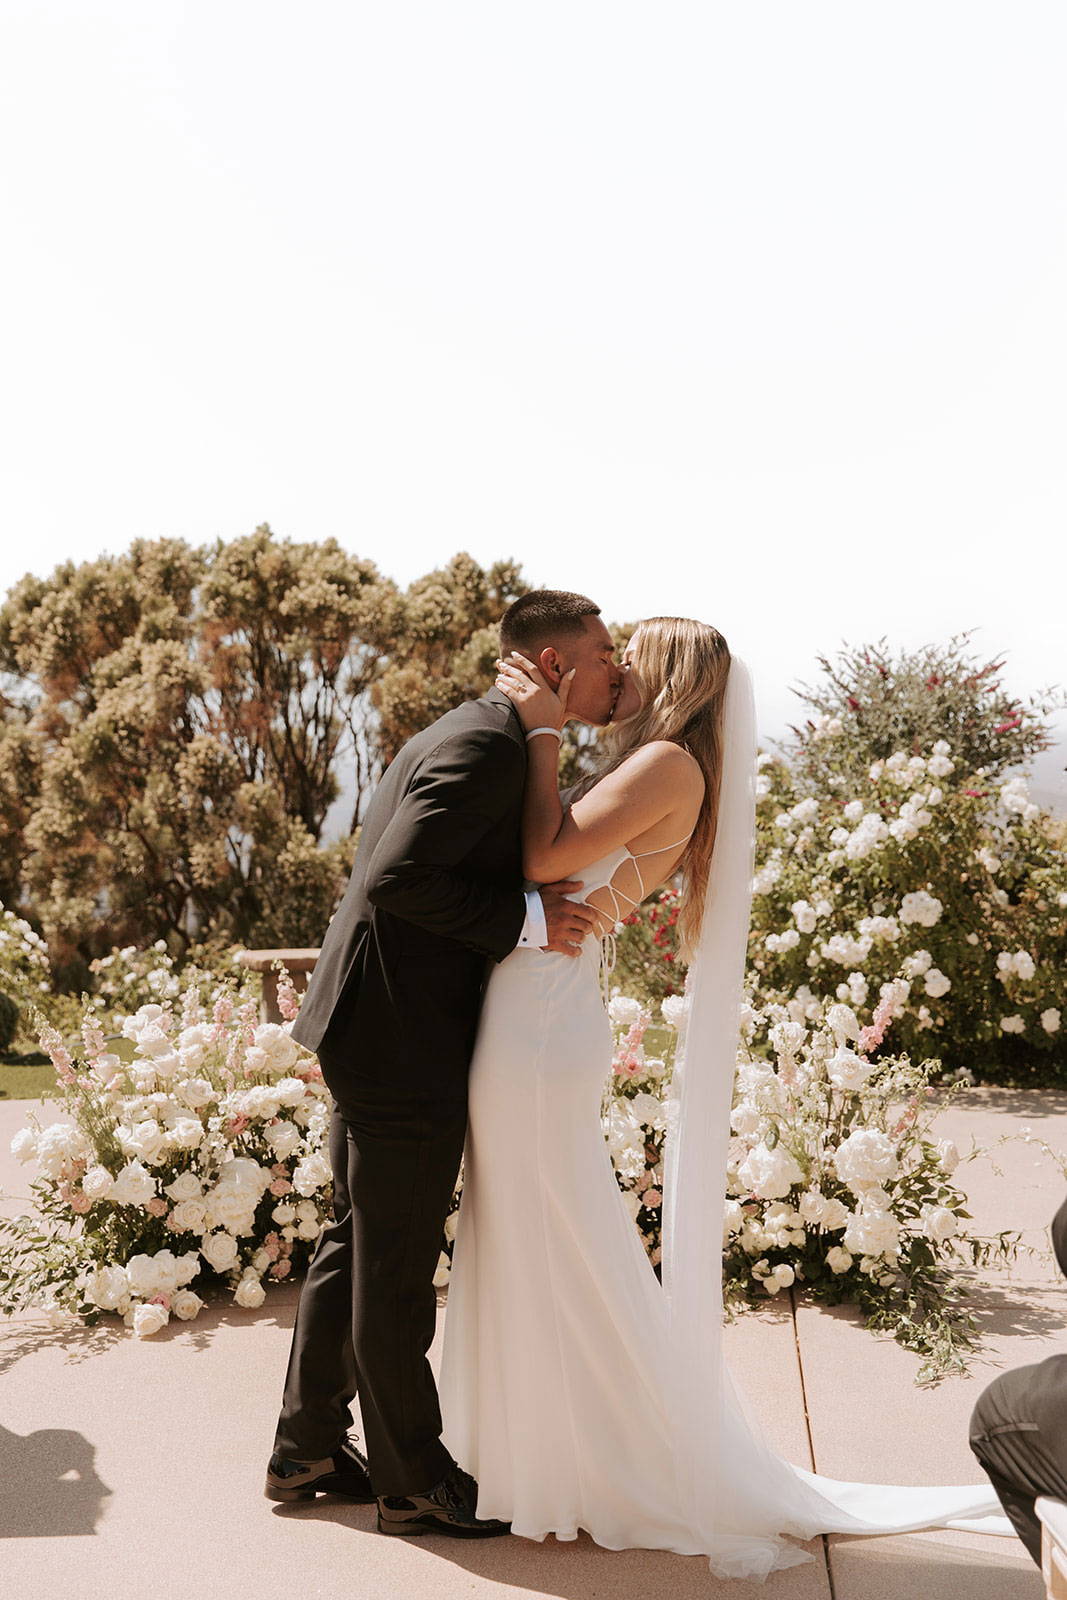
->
xmin=266 ymin=589 xmax=622 ymax=1538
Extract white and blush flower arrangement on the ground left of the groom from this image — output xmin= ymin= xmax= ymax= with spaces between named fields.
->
xmin=0 ymin=976 xmax=331 ymax=1338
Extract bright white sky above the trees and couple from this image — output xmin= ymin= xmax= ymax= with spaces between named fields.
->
xmin=0 ymin=0 xmax=1067 ymax=794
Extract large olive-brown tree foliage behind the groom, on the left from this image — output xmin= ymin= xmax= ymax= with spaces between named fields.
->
xmin=0 ymin=523 xmax=522 ymax=984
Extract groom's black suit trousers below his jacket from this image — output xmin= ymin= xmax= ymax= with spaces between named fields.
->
xmin=275 ymin=1062 xmax=467 ymax=1494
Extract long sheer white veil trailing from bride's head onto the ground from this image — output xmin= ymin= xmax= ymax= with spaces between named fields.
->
xmin=662 ymin=656 xmax=1014 ymax=1578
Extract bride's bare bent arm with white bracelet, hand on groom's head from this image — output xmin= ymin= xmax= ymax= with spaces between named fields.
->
xmin=498 ymin=652 xmax=704 ymax=883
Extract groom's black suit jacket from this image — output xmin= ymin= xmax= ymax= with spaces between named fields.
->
xmin=293 ymin=690 xmax=526 ymax=1096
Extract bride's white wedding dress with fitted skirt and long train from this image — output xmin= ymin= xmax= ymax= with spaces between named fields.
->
xmin=440 ymin=659 xmax=1014 ymax=1579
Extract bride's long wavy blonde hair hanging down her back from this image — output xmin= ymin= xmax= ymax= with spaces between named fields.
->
xmin=582 ymin=616 xmax=729 ymax=958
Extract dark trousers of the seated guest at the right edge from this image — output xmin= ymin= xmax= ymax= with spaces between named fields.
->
xmin=969 ymin=1355 xmax=1067 ymax=1566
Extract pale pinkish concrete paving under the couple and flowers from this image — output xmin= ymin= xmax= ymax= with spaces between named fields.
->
xmin=0 ymin=1088 xmax=1067 ymax=1600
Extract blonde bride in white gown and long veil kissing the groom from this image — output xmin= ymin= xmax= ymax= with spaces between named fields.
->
xmin=440 ymin=618 xmax=1013 ymax=1579
